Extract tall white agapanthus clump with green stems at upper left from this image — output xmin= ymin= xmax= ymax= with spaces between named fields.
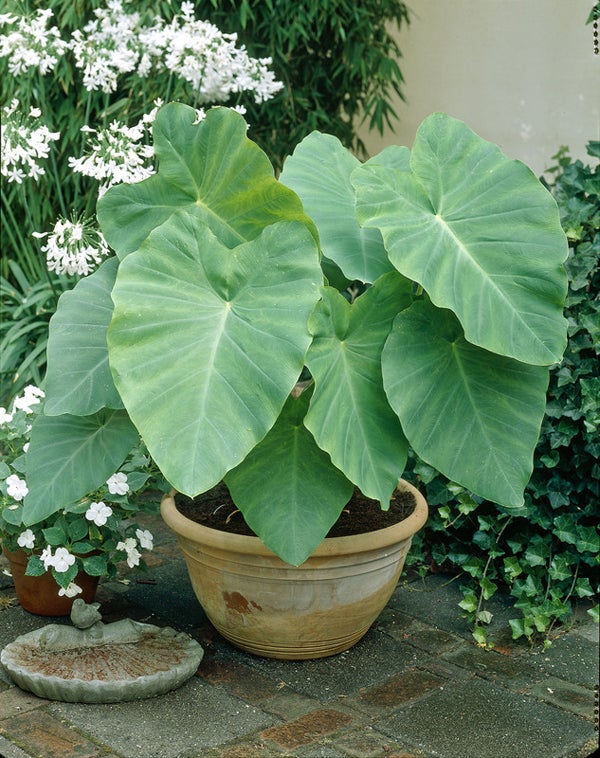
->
xmin=0 ymin=0 xmax=283 ymax=402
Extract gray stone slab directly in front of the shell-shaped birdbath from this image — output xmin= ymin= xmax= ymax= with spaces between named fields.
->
xmin=47 ymin=677 xmax=277 ymax=758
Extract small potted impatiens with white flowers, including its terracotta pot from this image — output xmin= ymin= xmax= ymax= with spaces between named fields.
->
xmin=0 ymin=385 xmax=156 ymax=616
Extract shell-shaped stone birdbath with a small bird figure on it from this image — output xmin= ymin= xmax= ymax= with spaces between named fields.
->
xmin=0 ymin=599 xmax=204 ymax=703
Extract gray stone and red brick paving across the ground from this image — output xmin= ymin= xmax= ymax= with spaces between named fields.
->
xmin=0 ymin=510 xmax=598 ymax=758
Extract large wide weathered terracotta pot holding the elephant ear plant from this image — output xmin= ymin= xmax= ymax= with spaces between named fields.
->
xmin=161 ymin=481 xmax=427 ymax=660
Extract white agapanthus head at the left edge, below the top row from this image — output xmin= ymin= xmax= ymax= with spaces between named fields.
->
xmin=0 ymin=99 xmax=60 ymax=184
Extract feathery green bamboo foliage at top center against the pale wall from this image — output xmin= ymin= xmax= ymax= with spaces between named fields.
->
xmin=196 ymin=0 xmax=409 ymax=168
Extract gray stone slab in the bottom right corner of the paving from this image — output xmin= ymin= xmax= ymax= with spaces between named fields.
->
xmin=377 ymin=679 xmax=594 ymax=758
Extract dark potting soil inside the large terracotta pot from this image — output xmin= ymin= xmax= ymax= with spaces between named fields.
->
xmin=175 ymin=483 xmax=416 ymax=537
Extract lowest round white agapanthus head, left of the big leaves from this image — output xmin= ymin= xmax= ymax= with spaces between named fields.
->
xmin=33 ymin=217 xmax=109 ymax=276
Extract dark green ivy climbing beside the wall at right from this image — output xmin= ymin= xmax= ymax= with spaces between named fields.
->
xmin=411 ymin=142 xmax=600 ymax=643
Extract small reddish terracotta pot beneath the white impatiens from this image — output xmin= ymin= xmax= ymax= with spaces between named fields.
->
xmin=2 ymin=547 xmax=100 ymax=616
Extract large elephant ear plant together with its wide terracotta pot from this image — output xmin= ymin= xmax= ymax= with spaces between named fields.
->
xmin=24 ymin=103 xmax=567 ymax=658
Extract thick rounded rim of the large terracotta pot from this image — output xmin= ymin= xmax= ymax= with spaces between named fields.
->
xmin=160 ymin=479 xmax=429 ymax=559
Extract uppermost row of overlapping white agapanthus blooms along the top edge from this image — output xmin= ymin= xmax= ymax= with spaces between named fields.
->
xmin=0 ymin=0 xmax=283 ymax=103
